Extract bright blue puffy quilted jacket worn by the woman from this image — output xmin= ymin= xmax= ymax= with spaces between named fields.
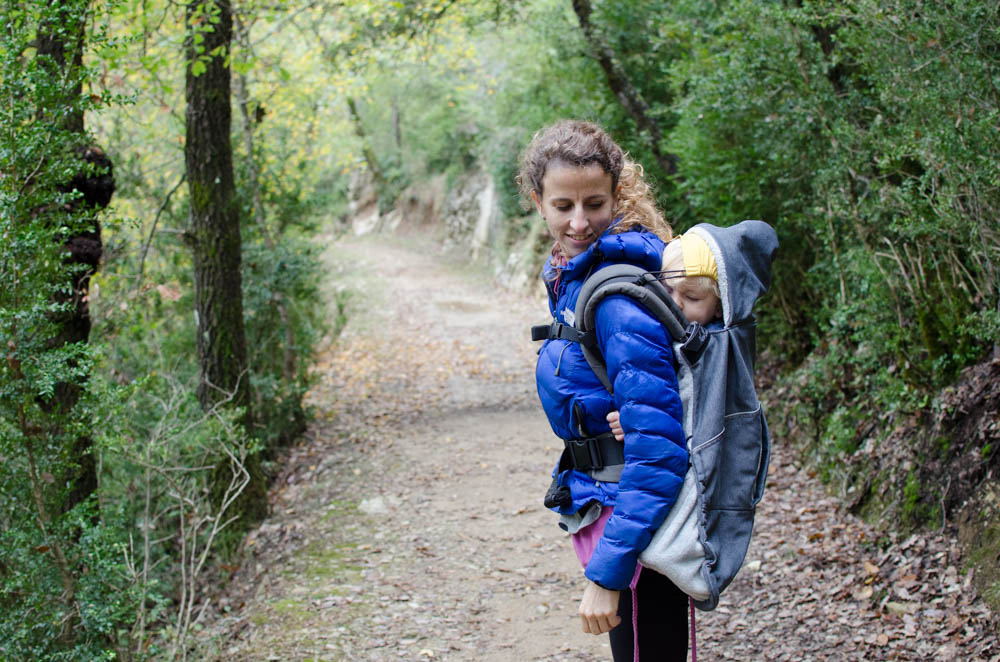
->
xmin=535 ymin=232 xmax=688 ymax=590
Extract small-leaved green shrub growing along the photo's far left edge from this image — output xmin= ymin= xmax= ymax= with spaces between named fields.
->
xmin=0 ymin=3 xmax=135 ymax=660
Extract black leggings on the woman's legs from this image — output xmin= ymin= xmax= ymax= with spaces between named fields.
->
xmin=608 ymin=568 xmax=688 ymax=662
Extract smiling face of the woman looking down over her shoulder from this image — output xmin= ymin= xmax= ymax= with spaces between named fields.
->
xmin=531 ymin=163 xmax=615 ymax=259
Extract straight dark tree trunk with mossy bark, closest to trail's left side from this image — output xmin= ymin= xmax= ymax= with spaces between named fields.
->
xmin=184 ymin=0 xmax=267 ymax=531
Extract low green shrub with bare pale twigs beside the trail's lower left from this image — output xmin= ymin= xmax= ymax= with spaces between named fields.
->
xmin=93 ymin=375 xmax=259 ymax=659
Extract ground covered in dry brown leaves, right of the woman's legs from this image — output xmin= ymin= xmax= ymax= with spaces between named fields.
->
xmin=698 ymin=456 xmax=1000 ymax=662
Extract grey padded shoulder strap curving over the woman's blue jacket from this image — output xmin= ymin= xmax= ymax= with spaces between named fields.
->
xmin=574 ymin=264 xmax=687 ymax=393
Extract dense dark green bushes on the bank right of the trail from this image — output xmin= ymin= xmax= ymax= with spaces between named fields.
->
xmin=648 ymin=0 xmax=1000 ymax=527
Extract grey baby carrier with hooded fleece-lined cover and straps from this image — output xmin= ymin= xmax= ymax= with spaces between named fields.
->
xmin=532 ymin=221 xmax=778 ymax=611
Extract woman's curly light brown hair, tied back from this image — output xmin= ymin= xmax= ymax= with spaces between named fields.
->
xmin=515 ymin=120 xmax=674 ymax=242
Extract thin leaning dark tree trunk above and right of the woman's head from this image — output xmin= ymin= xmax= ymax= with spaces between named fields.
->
xmin=573 ymin=0 xmax=677 ymax=175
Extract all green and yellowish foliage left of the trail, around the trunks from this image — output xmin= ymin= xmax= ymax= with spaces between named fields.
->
xmin=6 ymin=3 xmax=328 ymax=660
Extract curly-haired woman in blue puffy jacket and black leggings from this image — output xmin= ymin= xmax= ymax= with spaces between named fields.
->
xmin=517 ymin=120 xmax=688 ymax=662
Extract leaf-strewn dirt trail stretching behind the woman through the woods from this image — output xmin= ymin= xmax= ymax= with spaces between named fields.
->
xmin=201 ymin=231 xmax=1000 ymax=662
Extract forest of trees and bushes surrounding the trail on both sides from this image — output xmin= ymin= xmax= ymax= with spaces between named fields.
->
xmin=0 ymin=0 xmax=1000 ymax=660
